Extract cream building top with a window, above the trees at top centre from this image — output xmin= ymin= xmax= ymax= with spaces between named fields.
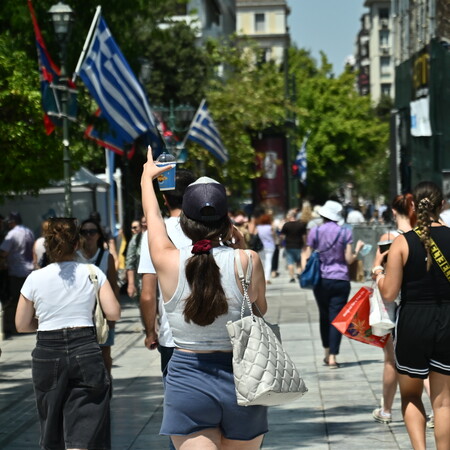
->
xmin=236 ymin=0 xmax=290 ymax=64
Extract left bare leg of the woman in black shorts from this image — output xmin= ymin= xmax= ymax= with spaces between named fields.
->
xmin=398 ymin=374 xmax=428 ymax=450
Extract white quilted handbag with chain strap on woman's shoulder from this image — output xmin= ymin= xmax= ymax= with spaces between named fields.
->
xmin=227 ymin=250 xmax=308 ymax=406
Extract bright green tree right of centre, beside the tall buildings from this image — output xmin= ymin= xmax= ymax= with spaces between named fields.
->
xmin=290 ymin=48 xmax=389 ymax=202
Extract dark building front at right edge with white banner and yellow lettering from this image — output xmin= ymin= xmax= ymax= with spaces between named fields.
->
xmin=391 ymin=0 xmax=450 ymax=197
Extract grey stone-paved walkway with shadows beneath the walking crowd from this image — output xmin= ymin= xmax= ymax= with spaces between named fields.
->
xmin=0 ymin=273 xmax=435 ymax=450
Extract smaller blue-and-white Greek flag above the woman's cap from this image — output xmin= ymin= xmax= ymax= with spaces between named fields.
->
xmin=184 ymin=99 xmax=229 ymax=163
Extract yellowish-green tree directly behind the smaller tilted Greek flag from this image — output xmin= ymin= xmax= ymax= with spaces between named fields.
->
xmin=181 ymin=42 xmax=290 ymax=195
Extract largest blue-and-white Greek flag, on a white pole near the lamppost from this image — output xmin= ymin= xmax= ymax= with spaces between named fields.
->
xmin=78 ymin=17 xmax=157 ymax=143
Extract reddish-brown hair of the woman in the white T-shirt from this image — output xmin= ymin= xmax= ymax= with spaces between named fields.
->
xmin=44 ymin=217 xmax=80 ymax=262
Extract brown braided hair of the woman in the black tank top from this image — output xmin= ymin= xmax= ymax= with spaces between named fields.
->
xmin=413 ymin=181 xmax=443 ymax=270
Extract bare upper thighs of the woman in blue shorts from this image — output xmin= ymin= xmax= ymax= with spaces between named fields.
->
xmin=171 ymin=428 xmax=264 ymax=450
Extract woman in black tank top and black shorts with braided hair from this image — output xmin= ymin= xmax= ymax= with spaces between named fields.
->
xmin=374 ymin=181 xmax=450 ymax=449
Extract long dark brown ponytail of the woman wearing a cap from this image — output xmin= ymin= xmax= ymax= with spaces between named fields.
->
xmin=180 ymin=213 xmax=231 ymax=326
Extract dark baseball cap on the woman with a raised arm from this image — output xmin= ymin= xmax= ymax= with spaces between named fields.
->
xmin=182 ymin=177 xmax=228 ymax=222
